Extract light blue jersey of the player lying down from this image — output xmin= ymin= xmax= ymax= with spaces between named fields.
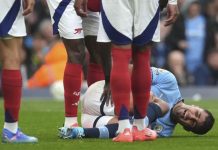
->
xmin=151 ymin=67 xmax=182 ymax=137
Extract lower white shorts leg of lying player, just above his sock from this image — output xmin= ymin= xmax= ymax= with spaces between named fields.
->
xmin=81 ymin=114 xmax=113 ymax=128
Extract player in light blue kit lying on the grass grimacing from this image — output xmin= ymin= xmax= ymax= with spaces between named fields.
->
xmin=60 ymin=67 xmax=214 ymax=138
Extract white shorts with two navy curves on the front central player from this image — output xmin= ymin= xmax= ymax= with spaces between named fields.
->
xmin=98 ymin=0 xmax=160 ymax=45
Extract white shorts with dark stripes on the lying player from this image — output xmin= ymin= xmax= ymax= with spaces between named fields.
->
xmin=81 ymin=80 xmax=114 ymax=128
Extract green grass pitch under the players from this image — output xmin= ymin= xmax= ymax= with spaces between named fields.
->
xmin=0 ymin=100 xmax=218 ymax=150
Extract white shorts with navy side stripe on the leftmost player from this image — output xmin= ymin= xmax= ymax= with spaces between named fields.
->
xmin=0 ymin=0 xmax=26 ymax=38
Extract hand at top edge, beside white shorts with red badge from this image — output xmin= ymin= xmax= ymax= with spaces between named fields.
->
xmin=74 ymin=0 xmax=88 ymax=17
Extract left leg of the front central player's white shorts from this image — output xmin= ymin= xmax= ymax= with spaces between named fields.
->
xmin=100 ymin=0 xmax=133 ymax=44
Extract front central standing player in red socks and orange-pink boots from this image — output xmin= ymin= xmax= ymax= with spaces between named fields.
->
xmin=77 ymin=0 xmax=177 ymax=142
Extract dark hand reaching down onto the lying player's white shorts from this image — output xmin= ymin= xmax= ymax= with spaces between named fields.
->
xmin=100 ymin=83 xmax=113 ymax=106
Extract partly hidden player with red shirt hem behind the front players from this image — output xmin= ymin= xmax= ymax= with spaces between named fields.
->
xmin=79 ymin=0 xmax=111 ymax=100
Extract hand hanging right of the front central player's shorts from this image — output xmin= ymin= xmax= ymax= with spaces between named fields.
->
xmin=164 ymin=4 xmax=179 ymax=26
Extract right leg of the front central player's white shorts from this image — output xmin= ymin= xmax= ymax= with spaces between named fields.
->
xmin=133 ymin=0 xmax=160 ymax=45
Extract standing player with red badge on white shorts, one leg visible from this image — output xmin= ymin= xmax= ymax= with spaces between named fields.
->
xmin=47 ymin=0 xmax=85 ymax=127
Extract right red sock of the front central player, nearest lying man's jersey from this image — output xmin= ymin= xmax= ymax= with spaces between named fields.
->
xmin=131 ymin=50 xmax=151 ymax=123
